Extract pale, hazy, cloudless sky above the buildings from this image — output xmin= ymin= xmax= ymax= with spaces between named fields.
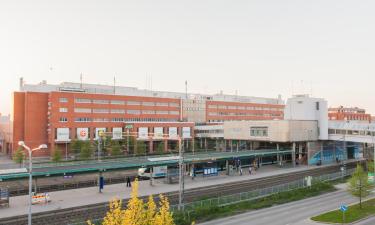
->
xmin=0 ymin=0 xmax=375 ymax=114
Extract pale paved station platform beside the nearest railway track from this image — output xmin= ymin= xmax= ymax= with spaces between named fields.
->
xmin=0 ymin=163 xmax=315 ymax=218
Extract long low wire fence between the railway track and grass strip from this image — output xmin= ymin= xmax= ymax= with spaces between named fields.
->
xmin=171 ymin=169 xmax=354 ymax=213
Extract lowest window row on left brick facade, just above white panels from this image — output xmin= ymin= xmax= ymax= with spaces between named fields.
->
xmin=59 ymin=117 xmax=177 ymax=123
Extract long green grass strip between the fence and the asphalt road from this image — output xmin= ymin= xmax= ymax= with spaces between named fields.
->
xmin=174 ymin=182 xmax=336 ymax=225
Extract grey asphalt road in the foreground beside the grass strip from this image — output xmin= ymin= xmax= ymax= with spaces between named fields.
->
xmin=201 ymin=190 xmax=375 ymax=225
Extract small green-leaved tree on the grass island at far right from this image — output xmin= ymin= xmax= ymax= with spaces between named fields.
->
xmin=348 ymin=164 xmax=372 ymax=209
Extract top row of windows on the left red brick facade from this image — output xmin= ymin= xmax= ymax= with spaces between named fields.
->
xmin=59 ymin=98 xmax=180 ymax=107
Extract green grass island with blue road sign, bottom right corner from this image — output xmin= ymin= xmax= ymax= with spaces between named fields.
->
xmin=311 ymin=198 xmax=375 ymax=223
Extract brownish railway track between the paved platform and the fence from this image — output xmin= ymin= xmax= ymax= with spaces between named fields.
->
xmin=0 ymin=162 xmax=362 ymax=225
